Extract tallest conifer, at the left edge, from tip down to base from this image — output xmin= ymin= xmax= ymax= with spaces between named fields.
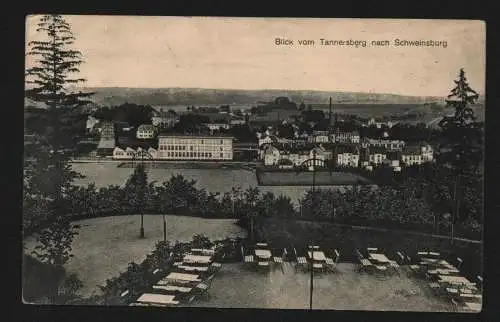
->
xmin=25 ymin=15 xmax=92 ymax=267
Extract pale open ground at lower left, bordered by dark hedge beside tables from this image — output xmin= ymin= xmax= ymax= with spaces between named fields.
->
xmin=26 ymin=215 xmax=246 ymax=296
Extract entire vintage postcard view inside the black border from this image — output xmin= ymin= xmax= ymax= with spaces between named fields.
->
xmin=22 ymin=14 xmax=486 ymax=314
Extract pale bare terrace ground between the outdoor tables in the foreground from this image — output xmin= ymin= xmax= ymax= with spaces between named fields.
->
xmin=184 ymin=263 xmax=468 ymax=312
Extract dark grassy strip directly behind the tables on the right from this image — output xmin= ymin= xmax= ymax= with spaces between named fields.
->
xmin=255 ymin=219 xmax=482 ymax=280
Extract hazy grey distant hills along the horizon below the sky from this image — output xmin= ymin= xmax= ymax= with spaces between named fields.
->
xmin=86 ymin=87 xmax=443 ymax=106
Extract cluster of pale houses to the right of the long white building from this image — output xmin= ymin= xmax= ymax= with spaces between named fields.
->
xmin=262 ymin=143 xmax=433 ymax=171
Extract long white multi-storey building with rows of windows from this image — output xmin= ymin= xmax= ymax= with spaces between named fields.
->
xmin=157 ymin=135 xmax=233 ymax=160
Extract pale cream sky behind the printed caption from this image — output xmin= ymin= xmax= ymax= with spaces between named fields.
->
xmin=26 ymin=15 xmax=486 ymax=96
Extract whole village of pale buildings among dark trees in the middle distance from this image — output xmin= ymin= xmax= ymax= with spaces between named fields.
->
xmin=25 ymin=89 xmax=483 ymax=177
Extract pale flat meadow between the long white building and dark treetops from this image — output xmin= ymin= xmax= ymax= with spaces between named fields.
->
xmin=72 ymin=162 xmax=345 ymax=204
